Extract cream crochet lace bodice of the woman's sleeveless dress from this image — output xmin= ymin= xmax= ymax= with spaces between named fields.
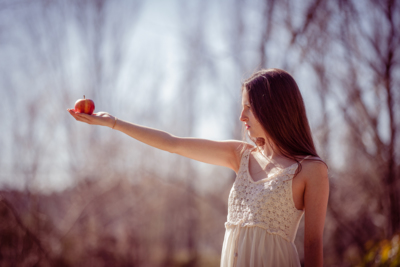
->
xmin=225 ymin=149 xmax=304 ymax=242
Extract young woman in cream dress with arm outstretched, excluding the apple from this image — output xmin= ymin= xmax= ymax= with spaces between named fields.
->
xmin=68 ymin=69 xmax=329 ymax=267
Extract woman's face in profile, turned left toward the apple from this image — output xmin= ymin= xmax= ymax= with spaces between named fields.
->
xmin=239 ymin=89 xmax=265 ymax=139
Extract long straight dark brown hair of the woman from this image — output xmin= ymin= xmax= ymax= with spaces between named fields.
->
xmin=242 ymin=68 xmax=319 ymax=174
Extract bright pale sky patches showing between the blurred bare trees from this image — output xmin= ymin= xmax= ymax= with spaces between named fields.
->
xmin=0 ymin=0 xmax=388 ymax=193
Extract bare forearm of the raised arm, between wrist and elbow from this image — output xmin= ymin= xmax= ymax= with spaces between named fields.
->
xmin=114 ymin=119 xmax=176 ymax=153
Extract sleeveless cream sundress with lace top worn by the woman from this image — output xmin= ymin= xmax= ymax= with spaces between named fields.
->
xmin=221 ymin=147 xmax=309 ymax=267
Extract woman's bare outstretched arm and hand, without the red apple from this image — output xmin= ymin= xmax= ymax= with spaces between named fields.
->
xmin=68 ymin=109 xmax=249 ymax=172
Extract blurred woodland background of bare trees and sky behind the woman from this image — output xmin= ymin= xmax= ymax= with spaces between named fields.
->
xmin=0 ymin=0 xmax=400 ymax=266
